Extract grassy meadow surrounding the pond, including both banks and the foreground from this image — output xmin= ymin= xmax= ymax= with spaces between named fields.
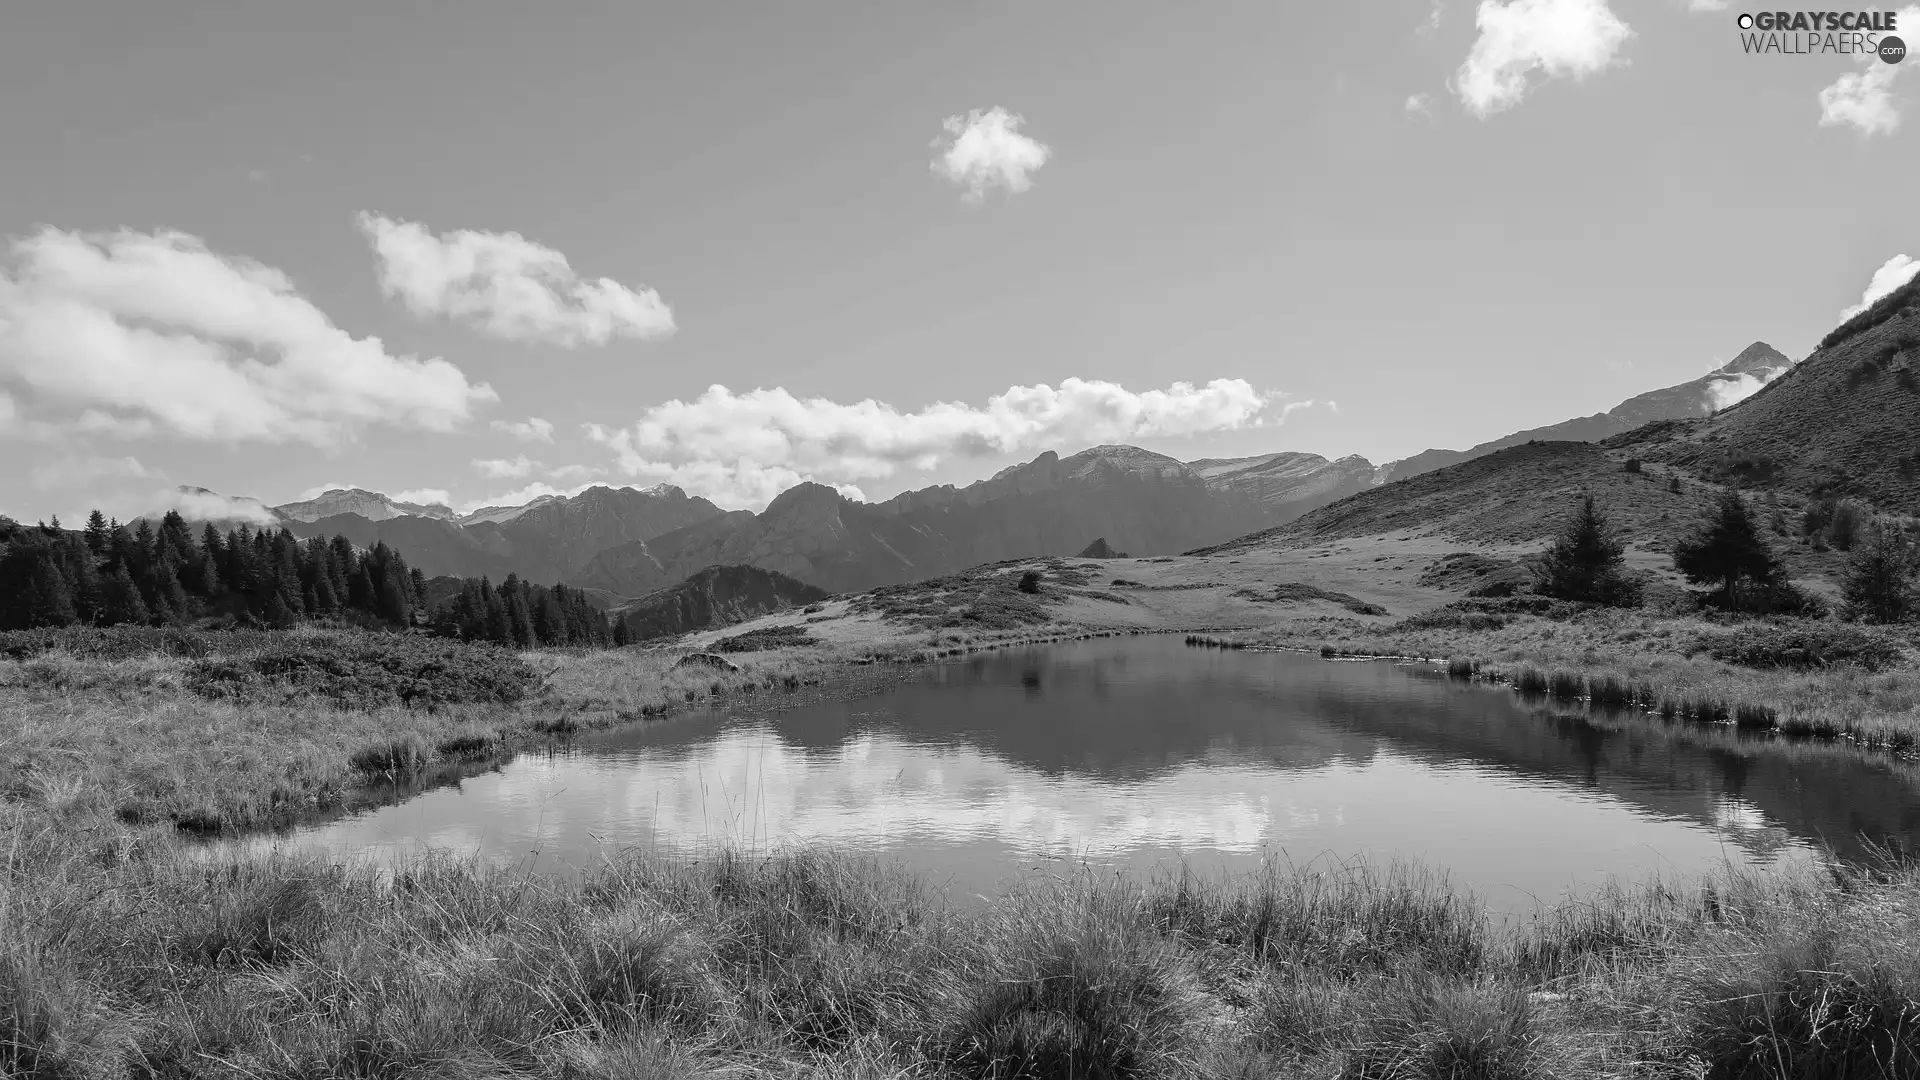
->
xmin=11 ymin=601 xmax=1920 ymax=1078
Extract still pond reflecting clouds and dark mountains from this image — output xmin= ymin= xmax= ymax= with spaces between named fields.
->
xmin=232 ymin=636 xmax=1920 ymax=911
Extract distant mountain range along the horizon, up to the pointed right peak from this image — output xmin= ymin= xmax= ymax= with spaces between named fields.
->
xmin=157 ymin=332 xmax=1820 ymax=598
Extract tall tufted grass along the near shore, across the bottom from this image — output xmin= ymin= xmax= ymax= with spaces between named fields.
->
xmin=0 ymin=819 xmax=1920 ymax=1080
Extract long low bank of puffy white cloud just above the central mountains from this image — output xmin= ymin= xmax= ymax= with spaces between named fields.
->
xmin=586 ymin=379 xmax=1309 ymax=505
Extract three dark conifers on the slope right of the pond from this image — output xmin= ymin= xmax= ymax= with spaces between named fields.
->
xmin=1534 ymin=488 xmax=1920 ymax=623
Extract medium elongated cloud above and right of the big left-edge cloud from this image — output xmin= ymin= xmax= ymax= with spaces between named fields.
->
xmin=359 ymin=213 xmax=674 ymax=348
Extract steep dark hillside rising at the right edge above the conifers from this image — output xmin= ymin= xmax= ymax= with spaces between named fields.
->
xmin=1607 ymin=279 xmax=1920 ymax=513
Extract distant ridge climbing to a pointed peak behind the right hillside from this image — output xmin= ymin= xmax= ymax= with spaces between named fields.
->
xmin=1380 ymin=342 xmax=1793 ymax=482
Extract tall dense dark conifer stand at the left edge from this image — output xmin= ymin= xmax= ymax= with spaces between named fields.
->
xmin=0 ymin=509 xmax=424 ymax=630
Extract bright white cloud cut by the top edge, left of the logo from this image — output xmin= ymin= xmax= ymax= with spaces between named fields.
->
xmin=1453 ymin=0 xmax=1634 ymax=117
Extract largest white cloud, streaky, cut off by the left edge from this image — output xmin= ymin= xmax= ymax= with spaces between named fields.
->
xmin=0 ymin=229 xmax=495 ymax=444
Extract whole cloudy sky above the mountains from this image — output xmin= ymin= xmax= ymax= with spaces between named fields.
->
xmin=0 ymin=0 xmax=1920 ymax=521
